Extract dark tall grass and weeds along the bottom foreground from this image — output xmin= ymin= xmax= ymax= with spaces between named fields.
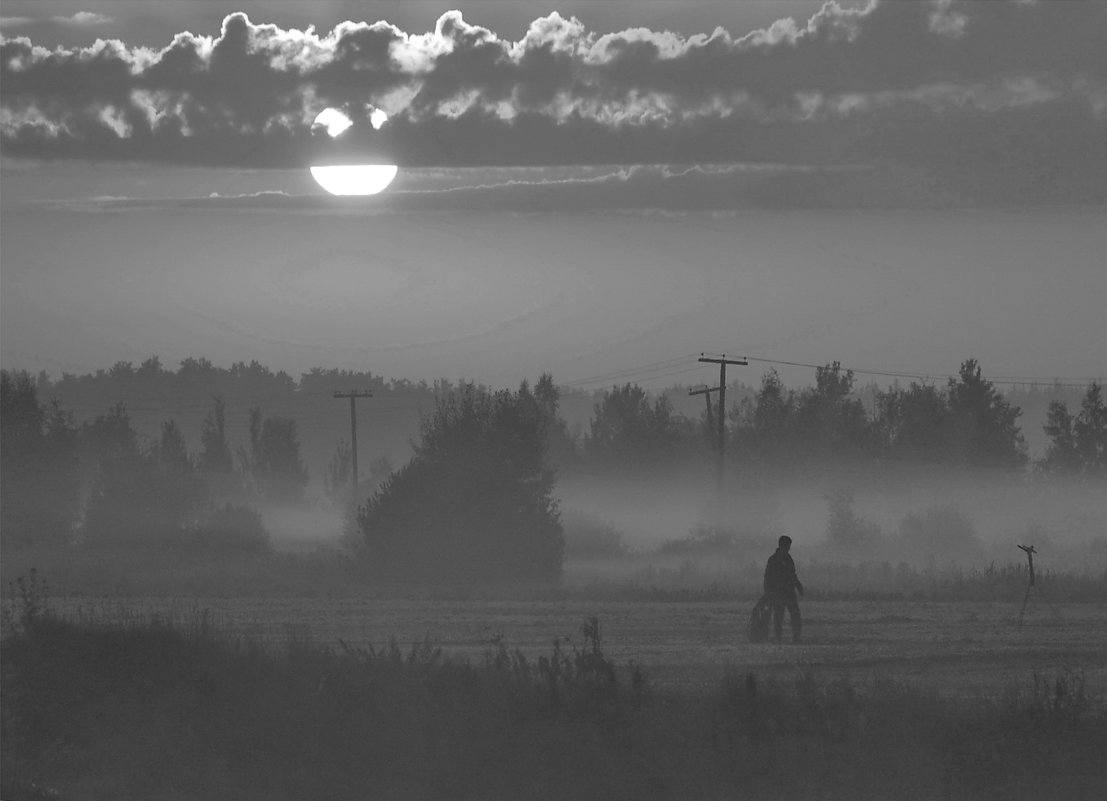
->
xmin=0 ymin=610 xmax=1107 ymax=801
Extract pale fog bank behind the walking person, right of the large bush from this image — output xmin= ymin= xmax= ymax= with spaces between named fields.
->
xmin=559 ymin=465 xmax=1107 ymax=571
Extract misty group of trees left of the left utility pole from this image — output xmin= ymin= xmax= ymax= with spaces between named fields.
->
xmin=0 ymin=371 xmax=308 ymax=551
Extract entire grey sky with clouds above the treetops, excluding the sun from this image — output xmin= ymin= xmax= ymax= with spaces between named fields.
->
xmin=0 ymin=0 xmax=1107 ymax=386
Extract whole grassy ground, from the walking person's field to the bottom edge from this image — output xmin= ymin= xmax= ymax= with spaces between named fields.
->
xmin=8 ymin=593 xmax=1107 ymax=801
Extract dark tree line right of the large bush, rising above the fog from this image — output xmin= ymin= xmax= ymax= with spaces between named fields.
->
xmin=578 ymin=358 xmax=1107 ymax=478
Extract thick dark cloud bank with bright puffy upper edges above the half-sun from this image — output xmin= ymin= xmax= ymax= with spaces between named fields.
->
xmin=0 ymin=0 xmax=1107 ymax=199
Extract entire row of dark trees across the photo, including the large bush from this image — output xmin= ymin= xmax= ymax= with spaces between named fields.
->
xmin=0 ymin=360 xmax=1107 ymax=578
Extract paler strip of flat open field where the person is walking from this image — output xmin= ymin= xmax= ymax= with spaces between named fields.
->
xmin=26 ymin=594 xmax=1107 ymax=700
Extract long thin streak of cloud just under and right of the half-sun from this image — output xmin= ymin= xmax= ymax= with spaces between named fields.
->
xmin=58 ymin=165 xmax=942 ymax=216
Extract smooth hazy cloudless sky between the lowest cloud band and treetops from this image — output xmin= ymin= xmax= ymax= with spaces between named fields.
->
xmin=0 ymin=184 xmax=1107 ymax=387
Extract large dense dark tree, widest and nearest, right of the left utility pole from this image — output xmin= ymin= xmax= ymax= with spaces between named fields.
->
xmin=358 ymin=383 xmax=565 ymax=580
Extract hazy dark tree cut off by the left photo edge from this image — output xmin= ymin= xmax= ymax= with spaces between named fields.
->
xmin=0 ymin=371 xmax=80 ymax=548
